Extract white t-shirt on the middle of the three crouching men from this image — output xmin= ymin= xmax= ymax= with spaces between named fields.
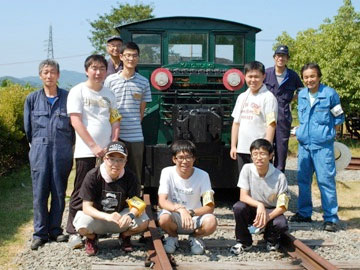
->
xmin=158 ymin=166 xmax=213 ymax=209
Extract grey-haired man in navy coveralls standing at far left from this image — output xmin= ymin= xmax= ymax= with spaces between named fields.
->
xmin=24 ymin=59 xmax=74 ymax=250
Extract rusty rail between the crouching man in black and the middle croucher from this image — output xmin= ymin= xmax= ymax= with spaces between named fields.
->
xmin=144 ymin=194 xmax=173 ymax=270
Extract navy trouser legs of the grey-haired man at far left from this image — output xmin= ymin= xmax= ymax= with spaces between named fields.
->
xmin=29 ymin=138 xmax=72 ymax=240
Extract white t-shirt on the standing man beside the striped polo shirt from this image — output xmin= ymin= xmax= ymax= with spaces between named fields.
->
xmin=67 ymin=82 xmax=116 ymax=158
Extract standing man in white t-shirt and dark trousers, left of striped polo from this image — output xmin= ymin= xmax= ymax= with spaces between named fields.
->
xmin=66 ymin=55 xmax=121 ymax=248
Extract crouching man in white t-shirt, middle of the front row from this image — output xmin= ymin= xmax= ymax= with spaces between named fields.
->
xmin=158 ymin=140 xmax=217 ymax=254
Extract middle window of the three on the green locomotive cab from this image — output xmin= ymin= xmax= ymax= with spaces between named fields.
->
xmin=168 ymin=33 xmax=208 ymax=64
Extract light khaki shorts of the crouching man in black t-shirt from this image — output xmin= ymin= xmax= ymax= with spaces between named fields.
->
xmin=73 ymin=208 xmax=149 ymax=234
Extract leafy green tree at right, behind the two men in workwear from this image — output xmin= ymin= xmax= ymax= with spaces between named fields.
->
xmin=274 ymin=0 xmax=360 ymax=114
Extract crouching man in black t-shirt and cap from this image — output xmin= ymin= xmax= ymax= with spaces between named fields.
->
xmin=73 ymin=142 xmax=149 ymax=256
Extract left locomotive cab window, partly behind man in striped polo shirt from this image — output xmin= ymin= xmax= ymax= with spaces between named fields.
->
xmin=132 ymin=34 xmax=161 ymax=65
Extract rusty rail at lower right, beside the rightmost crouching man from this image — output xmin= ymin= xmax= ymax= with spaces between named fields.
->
xmin=281 ymin=232 xmax=339 ymax=270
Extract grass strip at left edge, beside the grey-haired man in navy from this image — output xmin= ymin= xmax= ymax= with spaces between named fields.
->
xmin=0 ymin=166 xmax=33 ymax=269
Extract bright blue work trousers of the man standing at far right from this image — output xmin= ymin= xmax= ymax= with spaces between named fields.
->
xmin=297 ymin=144 xmax=339 ymax=223
